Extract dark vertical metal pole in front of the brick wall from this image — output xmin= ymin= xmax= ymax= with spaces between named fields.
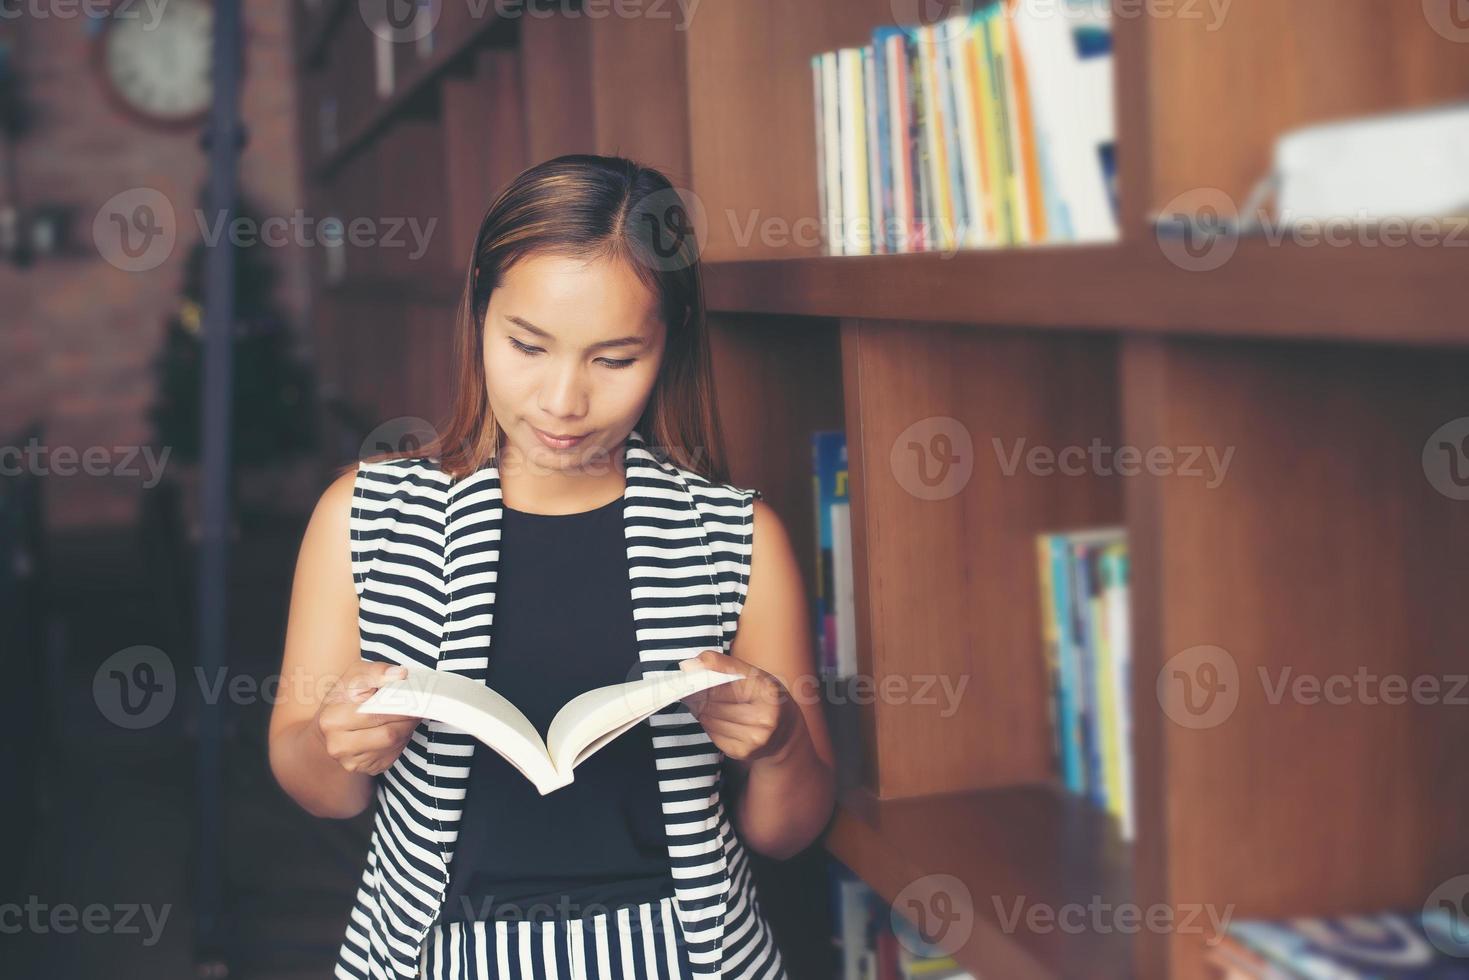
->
xmin=194 ymin=0 xmax=242 ymax=973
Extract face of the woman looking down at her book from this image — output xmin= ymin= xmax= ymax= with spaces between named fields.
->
xmin=483 ymin=256 xmax=667 ymax=473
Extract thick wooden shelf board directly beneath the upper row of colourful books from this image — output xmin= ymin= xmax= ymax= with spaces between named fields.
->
xmin=704 ymin=238 xmax=1469 ymax=345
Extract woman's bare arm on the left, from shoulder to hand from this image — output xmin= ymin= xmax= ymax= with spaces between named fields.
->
xmin=270 ymin=472 xmax=416 ymax=818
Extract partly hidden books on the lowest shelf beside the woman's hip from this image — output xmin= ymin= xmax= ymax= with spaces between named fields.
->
xmin=827 ymin=860 xmax=975 ymax=980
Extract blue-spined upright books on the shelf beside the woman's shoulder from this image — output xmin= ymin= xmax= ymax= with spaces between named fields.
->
xmin=811 ymin=429 xmax=856 ymax=677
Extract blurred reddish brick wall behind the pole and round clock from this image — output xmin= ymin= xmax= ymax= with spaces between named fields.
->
xmin=0 ymin=0 xmax=310 ymax=527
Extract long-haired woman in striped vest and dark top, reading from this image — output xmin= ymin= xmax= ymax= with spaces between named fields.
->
xmin=270 ymin=154 xmax=833 ymax=980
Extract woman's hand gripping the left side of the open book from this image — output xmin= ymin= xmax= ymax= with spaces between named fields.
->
xmin=311 ymin=660 xmax=423 ymax=776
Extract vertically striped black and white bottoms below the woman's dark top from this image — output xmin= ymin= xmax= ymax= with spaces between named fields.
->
xmin=419 ymin=898 xmax=695 ymax=980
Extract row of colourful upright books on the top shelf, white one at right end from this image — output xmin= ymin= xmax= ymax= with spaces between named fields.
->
xmin=811 ymin=0 xmax=1118 ymax=256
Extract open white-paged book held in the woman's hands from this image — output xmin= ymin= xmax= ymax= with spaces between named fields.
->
xmin=357 ymin=664 xmax=739 ymax=796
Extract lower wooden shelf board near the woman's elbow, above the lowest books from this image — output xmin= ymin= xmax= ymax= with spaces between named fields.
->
xmin=826 ymin=786 xmax=1133 ymax=980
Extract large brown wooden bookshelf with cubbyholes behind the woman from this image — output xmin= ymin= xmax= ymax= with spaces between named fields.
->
xmin=286 ymin=0 xmax=1469 ymax=980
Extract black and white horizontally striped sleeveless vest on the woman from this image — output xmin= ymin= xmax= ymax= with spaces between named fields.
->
xmin=335 ymin=429 xmax=784 ymax=980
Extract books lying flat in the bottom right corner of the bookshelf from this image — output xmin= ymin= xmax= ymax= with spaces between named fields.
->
xmin=1208 ymin=907 xmax=1469 ymax=980
